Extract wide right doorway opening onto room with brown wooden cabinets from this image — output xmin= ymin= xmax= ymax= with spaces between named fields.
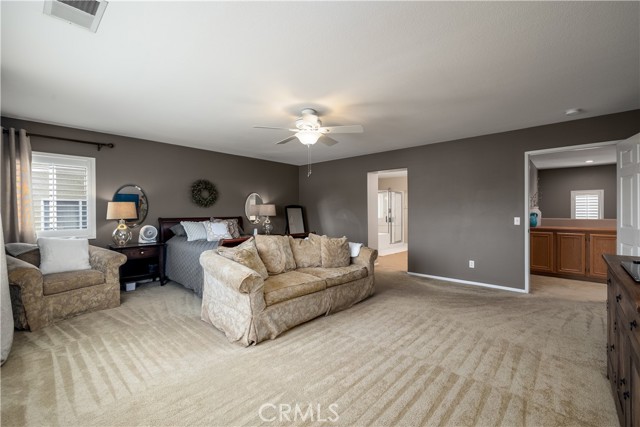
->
xmin=523 ymin=141 xmax=619 ymax=292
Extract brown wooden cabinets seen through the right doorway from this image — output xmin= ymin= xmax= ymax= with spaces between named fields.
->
xmin=529 ymin=227 xmax=616 ymax=283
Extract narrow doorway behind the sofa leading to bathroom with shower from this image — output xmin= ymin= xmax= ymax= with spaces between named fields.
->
xmin=367 ymin=169 xmax=409 ymax=271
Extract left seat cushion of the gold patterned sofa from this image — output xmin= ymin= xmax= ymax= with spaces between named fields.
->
xmin=264 ymin=271 xmax=327 ymax=306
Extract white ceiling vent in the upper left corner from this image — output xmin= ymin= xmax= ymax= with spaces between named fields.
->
xmin=44 ymin=0 xmax=108 ymax=33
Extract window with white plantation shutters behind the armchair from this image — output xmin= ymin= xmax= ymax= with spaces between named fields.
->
xmin=31 ymin=152 xmax=96 ymax=239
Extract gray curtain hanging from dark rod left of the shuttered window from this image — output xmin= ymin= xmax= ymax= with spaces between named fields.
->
xmin=0 ymin=128 xmax=36 ymax=243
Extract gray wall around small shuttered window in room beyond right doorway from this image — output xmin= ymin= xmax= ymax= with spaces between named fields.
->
xmin=538 ymin=165 xmax=616 ymax=219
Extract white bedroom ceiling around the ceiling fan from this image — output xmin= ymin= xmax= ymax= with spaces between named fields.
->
xmin=0 ymin=0 xmax=640 ymax=165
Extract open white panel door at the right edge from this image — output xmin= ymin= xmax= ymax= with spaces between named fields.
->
xmin=617 ymin=133 xmax=640 ymax=256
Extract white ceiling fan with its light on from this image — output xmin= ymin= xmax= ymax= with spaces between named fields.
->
xmin=254 ymin=108 xmax=364 ymax=147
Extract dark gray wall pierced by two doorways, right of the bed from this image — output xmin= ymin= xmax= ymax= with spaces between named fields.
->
xmin=299 ymin=110 xmax=640 ymax=289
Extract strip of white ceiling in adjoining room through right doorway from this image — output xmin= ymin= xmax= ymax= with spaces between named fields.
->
xmin=529 ymin=144 xmax=616 ymax=169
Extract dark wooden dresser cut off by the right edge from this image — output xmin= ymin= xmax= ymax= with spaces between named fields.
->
xmin=604 ymin=255 xmax=640 ymax=426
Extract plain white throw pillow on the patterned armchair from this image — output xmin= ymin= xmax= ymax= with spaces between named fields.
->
xmin=38 ymin=237 xmax=91 ymax=274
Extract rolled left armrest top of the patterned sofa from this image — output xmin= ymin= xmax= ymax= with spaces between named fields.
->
xmin=200 ymin=250 xmax=264 ymax=294
